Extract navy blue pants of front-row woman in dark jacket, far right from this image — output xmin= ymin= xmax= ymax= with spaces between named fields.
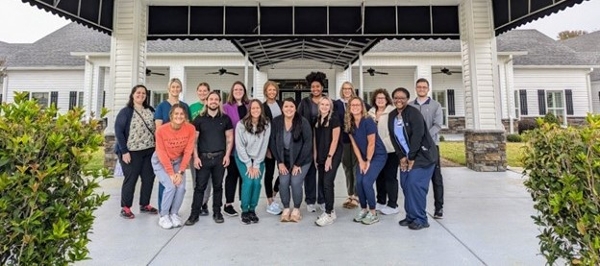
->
xmin=400 ymin=164 xmax=435 ymax=225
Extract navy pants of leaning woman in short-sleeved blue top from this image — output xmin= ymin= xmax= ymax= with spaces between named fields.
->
xmin=356 ymin=154 xmax=387 ymax=210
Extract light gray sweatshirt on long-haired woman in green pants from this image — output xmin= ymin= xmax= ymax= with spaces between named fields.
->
xmin=235 ymin=121 xmax=271 ymax=168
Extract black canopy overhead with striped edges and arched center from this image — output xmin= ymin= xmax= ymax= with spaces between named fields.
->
xmin=21 ymin=0 xmax=589 ymax=67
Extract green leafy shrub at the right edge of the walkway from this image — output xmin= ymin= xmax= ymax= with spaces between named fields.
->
xmin=523 ymin=115 xmax=600 ymax=265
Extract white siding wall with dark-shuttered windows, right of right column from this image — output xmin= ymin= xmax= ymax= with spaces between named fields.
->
xmin=514 ymin=68 xmax=598 ymax=116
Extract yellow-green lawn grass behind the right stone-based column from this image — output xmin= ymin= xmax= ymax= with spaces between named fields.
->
xmin=440 ymin=141 xmax=525 ymax=167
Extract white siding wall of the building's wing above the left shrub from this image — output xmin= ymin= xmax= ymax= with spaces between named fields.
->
xmin=3 ymin=69 xmax=84 ymax=113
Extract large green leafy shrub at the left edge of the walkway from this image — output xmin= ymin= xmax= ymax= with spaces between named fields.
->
xmin=0 ymin=93 xmax=108 ymax=265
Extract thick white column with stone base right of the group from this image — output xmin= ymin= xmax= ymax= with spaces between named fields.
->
xmin=459 ymin=0 xmax=506 ymax=172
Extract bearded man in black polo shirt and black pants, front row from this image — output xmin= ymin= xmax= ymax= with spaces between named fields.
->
xmin=185 ymin=92 xmax=233 ymax=225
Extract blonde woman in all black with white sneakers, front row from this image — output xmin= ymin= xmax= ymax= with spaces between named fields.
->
xmin=313 ymin=97 xmax=342 ymax=226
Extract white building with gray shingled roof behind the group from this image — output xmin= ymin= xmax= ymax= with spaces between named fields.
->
xmin=0 ymin=23 xmax=600 ymax=132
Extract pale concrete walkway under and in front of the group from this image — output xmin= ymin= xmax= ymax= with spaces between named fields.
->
xmin=77 ymin=167 xmax=545 ymax=265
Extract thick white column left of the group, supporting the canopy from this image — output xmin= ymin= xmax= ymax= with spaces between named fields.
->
xmin=104 ymin=0 xmax=148 ymax=169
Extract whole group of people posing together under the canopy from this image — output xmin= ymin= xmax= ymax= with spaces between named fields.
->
xmin=115 ymin=72 xmax=443 ymax=230
